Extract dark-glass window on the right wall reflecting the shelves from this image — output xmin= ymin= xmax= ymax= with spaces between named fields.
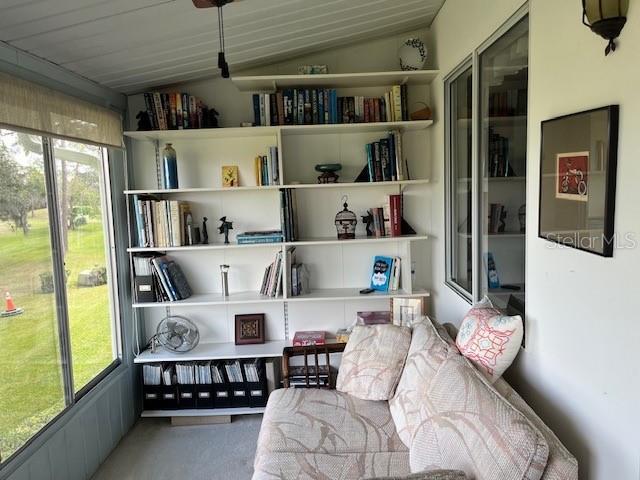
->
xmin=445 ymin=11 xmax=529 ymax=314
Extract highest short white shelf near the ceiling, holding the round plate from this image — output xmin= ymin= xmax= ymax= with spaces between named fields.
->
xmin=231 ymin=70 xmax=440 ymax=92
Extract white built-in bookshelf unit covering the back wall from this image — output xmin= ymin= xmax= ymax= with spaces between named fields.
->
xmin=124 ymin=71 xmax=438 ymax=402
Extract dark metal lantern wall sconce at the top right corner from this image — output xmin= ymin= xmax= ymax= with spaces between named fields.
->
xmin=582 ymin=0 xmax=629 ymax=55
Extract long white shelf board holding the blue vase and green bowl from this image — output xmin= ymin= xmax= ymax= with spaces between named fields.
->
xmin=124 ymin=177 xmax=430 ymax=195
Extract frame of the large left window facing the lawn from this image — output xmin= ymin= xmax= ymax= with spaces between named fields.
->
xmin=0 ymin=126 xmax=123 ymax=469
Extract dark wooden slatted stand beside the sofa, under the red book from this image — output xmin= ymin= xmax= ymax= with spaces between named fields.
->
xmin=282 ymin=343 xmax=346 ymax=388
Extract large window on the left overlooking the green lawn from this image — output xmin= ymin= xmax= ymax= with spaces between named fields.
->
xmin=0 ymin=130 xmax=119 ymax=461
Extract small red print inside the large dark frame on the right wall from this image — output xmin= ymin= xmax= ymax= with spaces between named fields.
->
xmin=556 ymin=152 xmax=589 ymax=202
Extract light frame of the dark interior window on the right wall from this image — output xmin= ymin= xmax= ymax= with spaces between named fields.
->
xmin=444 ymin=2 xmax=531 ymax=304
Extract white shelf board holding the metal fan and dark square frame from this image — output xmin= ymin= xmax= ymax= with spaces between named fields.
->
xmin=134 ymin=340 xmax=291 ymax=363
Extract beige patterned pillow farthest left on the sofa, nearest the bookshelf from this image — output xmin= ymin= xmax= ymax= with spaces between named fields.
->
xmin=336 ymin=324 xmax=411 ymax=400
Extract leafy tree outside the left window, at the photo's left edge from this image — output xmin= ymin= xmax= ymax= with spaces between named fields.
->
xmin=0 ymin=145 xmax=46 ymax=235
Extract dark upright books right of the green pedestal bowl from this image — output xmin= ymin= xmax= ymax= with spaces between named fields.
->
xmin=365 ymin=131 xmax=409 ymax=182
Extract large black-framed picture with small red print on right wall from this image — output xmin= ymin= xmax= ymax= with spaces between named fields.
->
xmin=538 ymin=105 xmax=619 ymax=257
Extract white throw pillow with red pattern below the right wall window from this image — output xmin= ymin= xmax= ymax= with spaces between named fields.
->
xmin=456 ymin=297 xmax=524 ymax=383
